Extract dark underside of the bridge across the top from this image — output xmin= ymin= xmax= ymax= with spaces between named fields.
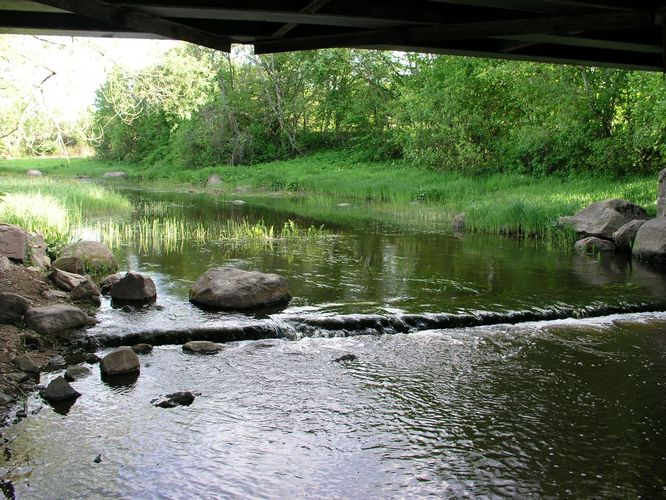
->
xmin=0 ymin=0 xmax=666 ymax=70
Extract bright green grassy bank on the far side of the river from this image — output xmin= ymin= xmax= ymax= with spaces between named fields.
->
xmin=0 ymin=151 xmax=657 ymax=243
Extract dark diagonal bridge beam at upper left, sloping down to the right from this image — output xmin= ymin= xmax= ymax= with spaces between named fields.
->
xmin=32 ymin=0 xmax=231 ymax=52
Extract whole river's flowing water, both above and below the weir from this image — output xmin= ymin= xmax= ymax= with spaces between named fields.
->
xmin=3 ymin=189 xmax=666 ymax=498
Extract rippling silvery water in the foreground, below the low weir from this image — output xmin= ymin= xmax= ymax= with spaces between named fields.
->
xmin=5 ymin=315 xmax=666 ymax=498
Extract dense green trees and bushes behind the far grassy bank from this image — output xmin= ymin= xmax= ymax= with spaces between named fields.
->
xmin=89 ymin=46 xmax=666 ymax=175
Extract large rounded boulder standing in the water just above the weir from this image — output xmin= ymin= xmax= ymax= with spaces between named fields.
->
xmin=190 ymin=267 xmax=291 ymax=310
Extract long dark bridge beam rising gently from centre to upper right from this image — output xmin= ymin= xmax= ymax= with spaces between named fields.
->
xmin=254 ymin=12 xmax=654 ymax=54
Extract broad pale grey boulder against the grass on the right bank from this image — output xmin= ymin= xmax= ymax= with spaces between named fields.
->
xmin=559 ymin=198 xmax=648 ymax=241
